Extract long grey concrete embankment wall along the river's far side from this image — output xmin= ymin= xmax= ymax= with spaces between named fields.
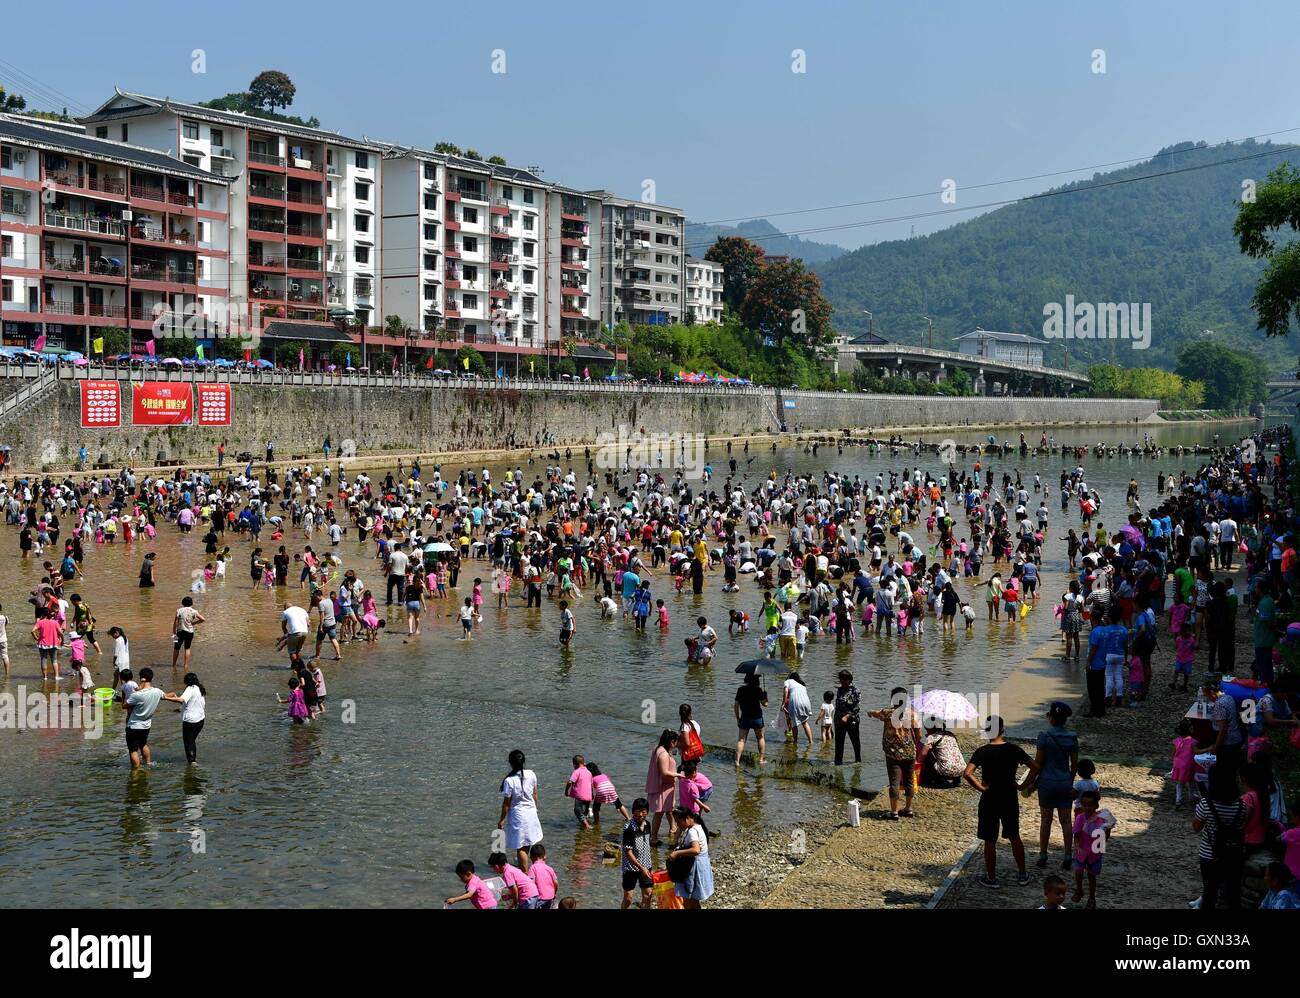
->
xmin=0 ymin=379 xmax=1157 ymax=469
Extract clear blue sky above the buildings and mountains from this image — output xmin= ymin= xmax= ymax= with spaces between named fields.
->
xmin=0 ymin=0 xmax=1300 ymax=247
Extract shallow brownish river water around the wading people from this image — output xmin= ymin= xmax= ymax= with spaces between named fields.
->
xmin=0 ymin=415 xmax=1240 ymax=907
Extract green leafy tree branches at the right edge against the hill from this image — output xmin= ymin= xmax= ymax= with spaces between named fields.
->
xmin=1232 ymin=162 xmax=1300 ymax=337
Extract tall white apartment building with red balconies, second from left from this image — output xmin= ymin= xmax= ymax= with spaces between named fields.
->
xmin=81 ymin=90 xmax=384 ymax=342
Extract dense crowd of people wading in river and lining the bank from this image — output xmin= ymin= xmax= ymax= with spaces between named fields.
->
xmin=0 ymin=434 xmax=1296 ymax=907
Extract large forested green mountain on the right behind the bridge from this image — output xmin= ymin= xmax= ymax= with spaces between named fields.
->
xmin=814 ymin=140 xmax=1300 ymax=369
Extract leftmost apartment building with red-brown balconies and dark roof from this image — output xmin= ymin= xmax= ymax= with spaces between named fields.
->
xmin=0 ymin=114 xmax=231 ymax=353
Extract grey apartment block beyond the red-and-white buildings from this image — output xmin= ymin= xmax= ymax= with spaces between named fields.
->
xmin=592 ymin=191 xmax=686 ymax=325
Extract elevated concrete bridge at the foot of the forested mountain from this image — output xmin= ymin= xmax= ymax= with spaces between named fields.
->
xmin=835 ymin=339 xmax=1092 ymax=395
